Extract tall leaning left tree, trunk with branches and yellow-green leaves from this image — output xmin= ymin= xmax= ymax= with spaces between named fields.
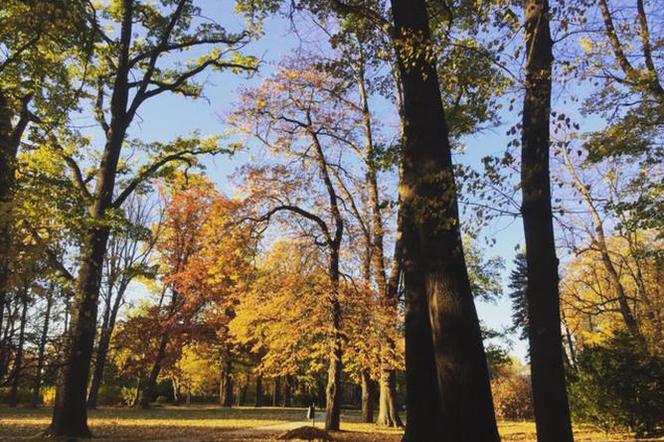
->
xmin=47 ymin=0 xmax=255 ymax=436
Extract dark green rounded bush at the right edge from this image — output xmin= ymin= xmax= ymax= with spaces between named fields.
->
xmin=569 ymin=332 xmax=664 ymax=437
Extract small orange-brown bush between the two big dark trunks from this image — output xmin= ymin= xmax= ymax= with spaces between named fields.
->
xmin=491 ymin=373 xmax=533 ymax=419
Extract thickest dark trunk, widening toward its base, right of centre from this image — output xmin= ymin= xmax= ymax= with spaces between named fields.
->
xmin=392 ymin=0 xmax=499 ymax=442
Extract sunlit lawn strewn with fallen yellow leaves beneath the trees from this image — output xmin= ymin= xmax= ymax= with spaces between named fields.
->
xmin=0 ymin=405 xmax=661 ymax=442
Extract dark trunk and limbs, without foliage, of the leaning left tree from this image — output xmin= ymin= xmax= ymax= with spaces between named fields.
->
xmin=46 ymin=0 xmax=253 ymax=437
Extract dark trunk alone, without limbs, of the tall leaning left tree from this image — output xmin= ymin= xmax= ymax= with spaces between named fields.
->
xmin=46 ymin=0 xmax=133 ymax=437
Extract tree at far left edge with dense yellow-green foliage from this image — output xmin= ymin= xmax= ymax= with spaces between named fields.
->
xmin=0 ymin=0 xmax=92 ymax=352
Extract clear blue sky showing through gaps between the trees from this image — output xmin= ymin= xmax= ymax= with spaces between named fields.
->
xmin=113 ymin=4 xmax=592 ymax=359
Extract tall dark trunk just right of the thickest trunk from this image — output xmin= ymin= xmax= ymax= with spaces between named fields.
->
xmin=521 ymin=0 xmax=573 ymax=442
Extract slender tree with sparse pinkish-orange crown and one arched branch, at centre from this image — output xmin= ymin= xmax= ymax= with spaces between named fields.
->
xmin=230 ymin=64 xmax=368 ymax=429
